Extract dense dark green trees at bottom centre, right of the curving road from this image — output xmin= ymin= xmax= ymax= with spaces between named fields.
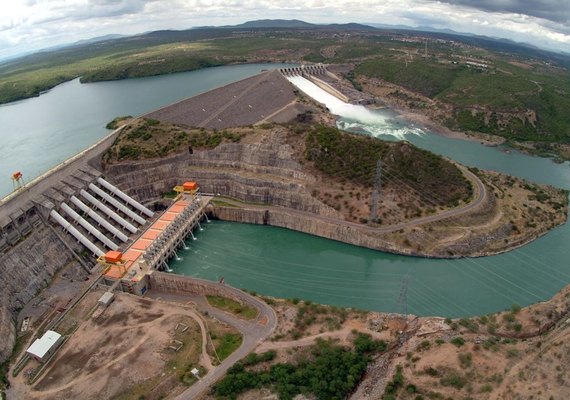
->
xmin=213 ymin=335 xmax=386 ymax=400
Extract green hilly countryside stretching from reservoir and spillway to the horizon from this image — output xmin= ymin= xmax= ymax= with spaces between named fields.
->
xmin=4 ymin=24 xmax=570 ymax=148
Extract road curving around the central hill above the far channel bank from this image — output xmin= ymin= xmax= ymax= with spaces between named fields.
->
xmin=206 ymin=165 xmax=487 ymax=233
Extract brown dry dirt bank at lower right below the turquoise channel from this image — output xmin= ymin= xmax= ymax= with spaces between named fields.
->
xmin=207 ymin=286 xmax=570 ymax=400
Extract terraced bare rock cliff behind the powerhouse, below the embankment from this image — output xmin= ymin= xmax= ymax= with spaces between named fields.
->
xmin=105 ymin=133 xmax=336 ymax=215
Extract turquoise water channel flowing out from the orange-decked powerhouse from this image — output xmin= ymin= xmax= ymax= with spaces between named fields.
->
xmin=170 ymin=221 xmax=570 ymax=317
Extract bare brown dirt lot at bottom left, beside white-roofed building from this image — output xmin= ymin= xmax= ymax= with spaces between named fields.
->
xmin=10 ymin=291 xmax=217 ymax=399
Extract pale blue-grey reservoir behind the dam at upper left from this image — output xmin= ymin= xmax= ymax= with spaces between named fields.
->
xmin=0 ymin=64 xmax=289 ymax=198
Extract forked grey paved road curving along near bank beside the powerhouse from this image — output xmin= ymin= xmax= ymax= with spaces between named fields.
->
xmin=145 ymin=283 xmax=277 ymax=400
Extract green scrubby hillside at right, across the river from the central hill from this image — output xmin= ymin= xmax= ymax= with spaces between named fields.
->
xmin=355 ymin=55 xmax=570 ymax=143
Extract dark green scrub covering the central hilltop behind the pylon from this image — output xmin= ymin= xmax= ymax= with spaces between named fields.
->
xmin=305 ymin=125 xmax=472 ymax=206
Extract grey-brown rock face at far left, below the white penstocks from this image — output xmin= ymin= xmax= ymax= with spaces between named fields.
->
xmin=0 ymin=225 xmax=79 ymax=362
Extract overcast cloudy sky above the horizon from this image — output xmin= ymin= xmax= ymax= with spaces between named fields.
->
xmin=0 ymin=0 xmax=570 ymax=59
